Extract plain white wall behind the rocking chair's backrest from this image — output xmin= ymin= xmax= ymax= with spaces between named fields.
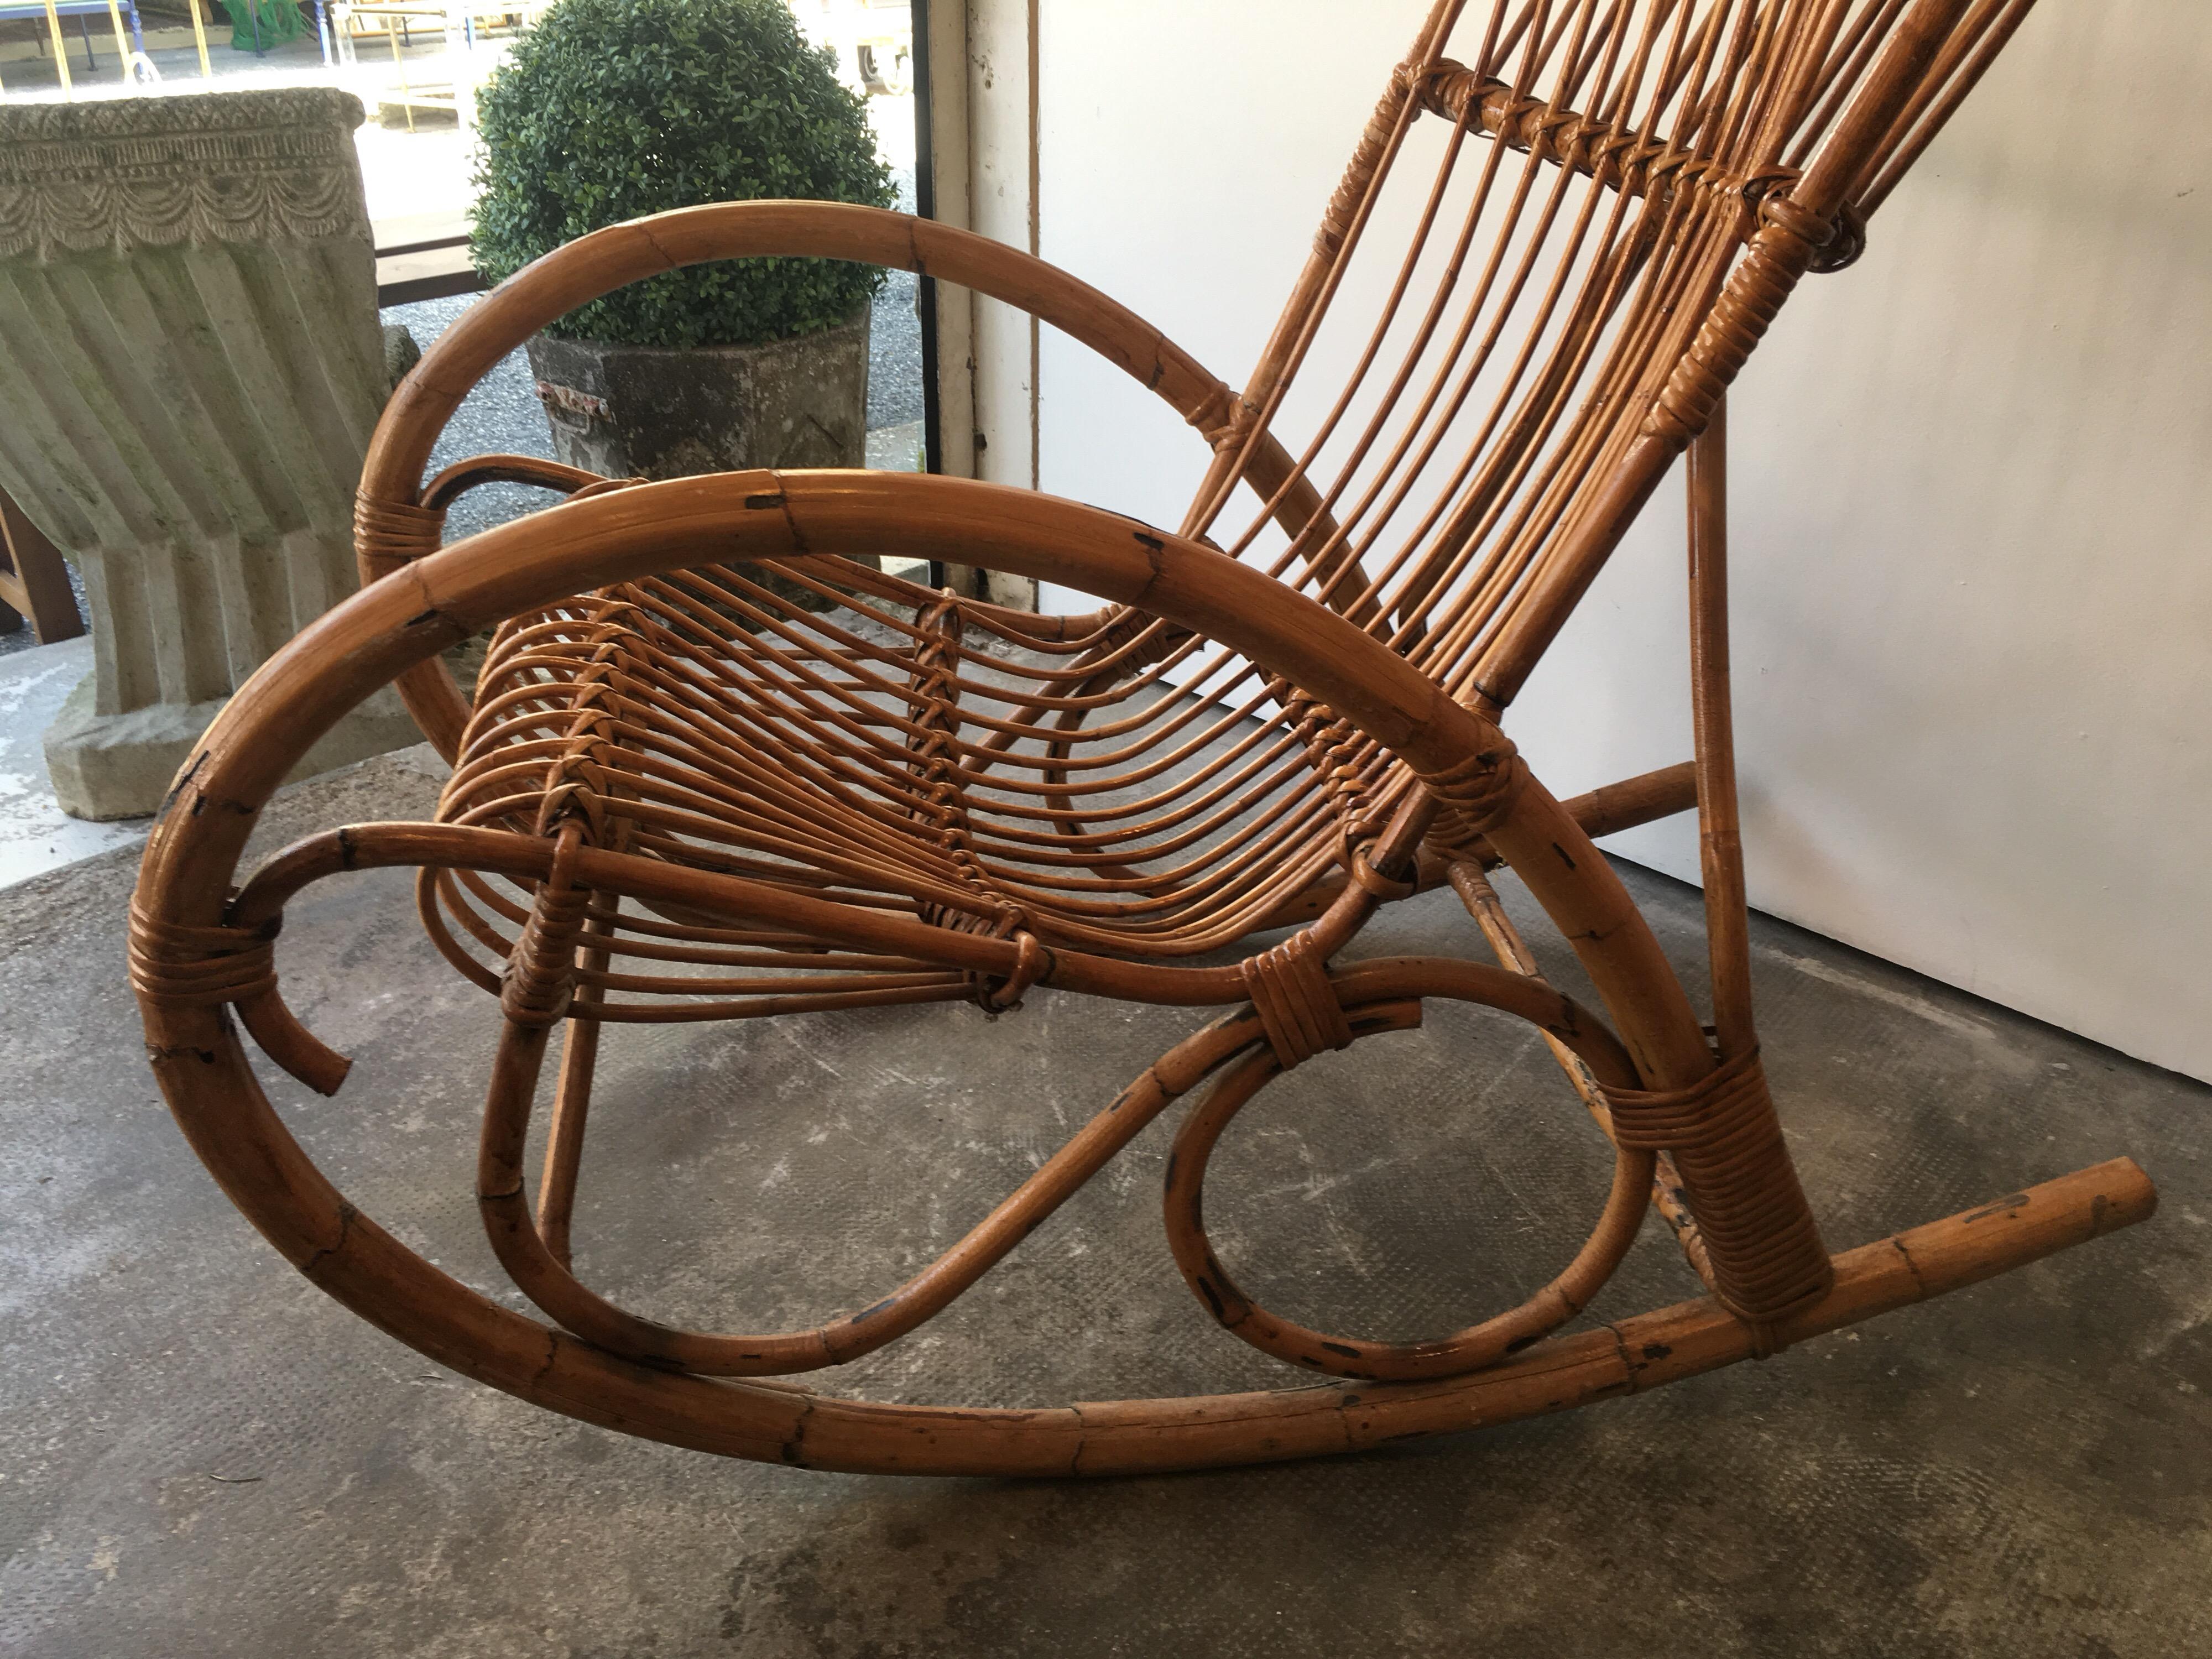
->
xmin=1004 ymin=0 xmax=2212 ymax=1077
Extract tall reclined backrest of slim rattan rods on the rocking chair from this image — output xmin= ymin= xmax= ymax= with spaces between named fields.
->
xmin=1183 ymin=0 xmax=2033 ymax=712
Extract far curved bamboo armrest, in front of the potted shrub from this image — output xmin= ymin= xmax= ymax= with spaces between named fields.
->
xmin=354 ymin=201 xmax=1321 ymax=761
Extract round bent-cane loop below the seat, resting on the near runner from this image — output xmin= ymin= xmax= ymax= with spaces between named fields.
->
xmin=1166 ymin=962 xmax=1657 ymax=1383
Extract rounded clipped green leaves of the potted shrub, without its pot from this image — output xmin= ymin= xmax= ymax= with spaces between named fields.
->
xmin=471 ymin=0 xmax=896 ymax=345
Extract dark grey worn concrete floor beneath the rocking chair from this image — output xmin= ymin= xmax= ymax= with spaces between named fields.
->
xmin=0 ymin=754 xmax=2212 ymax=1659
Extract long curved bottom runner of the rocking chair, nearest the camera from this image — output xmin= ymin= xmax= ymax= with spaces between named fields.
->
xmin=134 ymin=973 xmax=2157 ymax=1475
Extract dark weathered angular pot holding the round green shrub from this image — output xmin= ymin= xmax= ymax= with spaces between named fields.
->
xmin=529 ymin=305 xmax=867 ymax=478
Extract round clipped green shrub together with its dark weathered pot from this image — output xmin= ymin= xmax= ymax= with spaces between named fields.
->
xmin=473 ymin=0 xmax=894 ymax=478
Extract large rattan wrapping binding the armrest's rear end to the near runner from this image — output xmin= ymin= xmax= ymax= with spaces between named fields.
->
xmin=1604 ymin=1048 xmax=1834 ymax=1323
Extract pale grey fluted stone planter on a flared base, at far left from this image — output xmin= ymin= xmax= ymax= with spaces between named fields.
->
xmin=0 ymin=88 xmax=418 ymax=818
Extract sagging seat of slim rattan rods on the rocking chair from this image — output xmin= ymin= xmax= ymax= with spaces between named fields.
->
xmin=416 ymin=562 xmax=1343 ymax=1018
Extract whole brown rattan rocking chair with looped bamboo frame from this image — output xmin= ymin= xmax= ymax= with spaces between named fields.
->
xmin=131 ymin=0 xmax=2154 ymax=1475
